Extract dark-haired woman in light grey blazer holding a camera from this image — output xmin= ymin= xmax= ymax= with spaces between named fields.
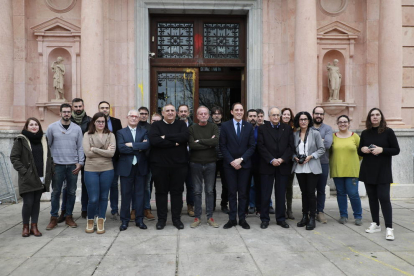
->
xmin=292 ymin=111 xmax=325 ymax=230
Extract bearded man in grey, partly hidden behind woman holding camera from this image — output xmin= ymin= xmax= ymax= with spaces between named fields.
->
xmin=312 ymin=106 xmax=333 ymax=223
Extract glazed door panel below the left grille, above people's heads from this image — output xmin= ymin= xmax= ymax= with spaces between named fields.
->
xmin=158 ymin=73 xmax=194 ymax=117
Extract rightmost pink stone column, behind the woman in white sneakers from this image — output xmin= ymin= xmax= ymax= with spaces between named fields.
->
xmin=378 ymin=0 xmax=404 ymax=126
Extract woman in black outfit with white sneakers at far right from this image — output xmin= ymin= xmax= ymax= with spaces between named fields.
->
xmin=358 ymin=108 xmax=400 ymax=240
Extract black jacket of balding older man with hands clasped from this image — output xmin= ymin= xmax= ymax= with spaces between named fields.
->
xmin=257 ymin=121 xmax=295 ymax=175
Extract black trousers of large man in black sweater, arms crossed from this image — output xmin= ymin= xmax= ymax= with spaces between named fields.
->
xmin=151 ymin=164 xmax=188 ymax=222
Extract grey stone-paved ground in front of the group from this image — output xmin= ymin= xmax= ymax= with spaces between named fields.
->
xmin=0 ymin=198 xmax=414 ymax=276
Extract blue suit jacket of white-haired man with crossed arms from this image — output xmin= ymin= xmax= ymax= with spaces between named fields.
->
xmin=116 ymin=127 xmax=149 ymax=176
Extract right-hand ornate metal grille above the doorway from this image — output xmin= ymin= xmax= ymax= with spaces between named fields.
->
xmin=204 ymin=24 xmax=239 ymax=58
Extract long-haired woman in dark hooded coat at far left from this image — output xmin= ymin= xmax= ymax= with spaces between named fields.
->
xmin=10 ymin=118 xmax=53 ymax=237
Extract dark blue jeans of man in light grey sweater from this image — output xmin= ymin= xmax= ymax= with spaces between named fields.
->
xmin=50 ymin=164 xmax=78 ymax=217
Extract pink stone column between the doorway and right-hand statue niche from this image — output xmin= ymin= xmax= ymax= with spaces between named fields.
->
xmin=294 ymin=0 xmax=318 ymax=113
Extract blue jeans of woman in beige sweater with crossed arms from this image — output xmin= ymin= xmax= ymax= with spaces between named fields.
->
xmin=85 ymin=170 xmax=114 ymax=219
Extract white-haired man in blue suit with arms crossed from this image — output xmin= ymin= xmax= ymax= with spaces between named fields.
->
xmin=116 ymin=110 xmax=149 ymax=231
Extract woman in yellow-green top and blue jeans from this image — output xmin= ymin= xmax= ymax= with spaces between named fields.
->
xmin=329 ymin=115 xmax=362 ymax=226
